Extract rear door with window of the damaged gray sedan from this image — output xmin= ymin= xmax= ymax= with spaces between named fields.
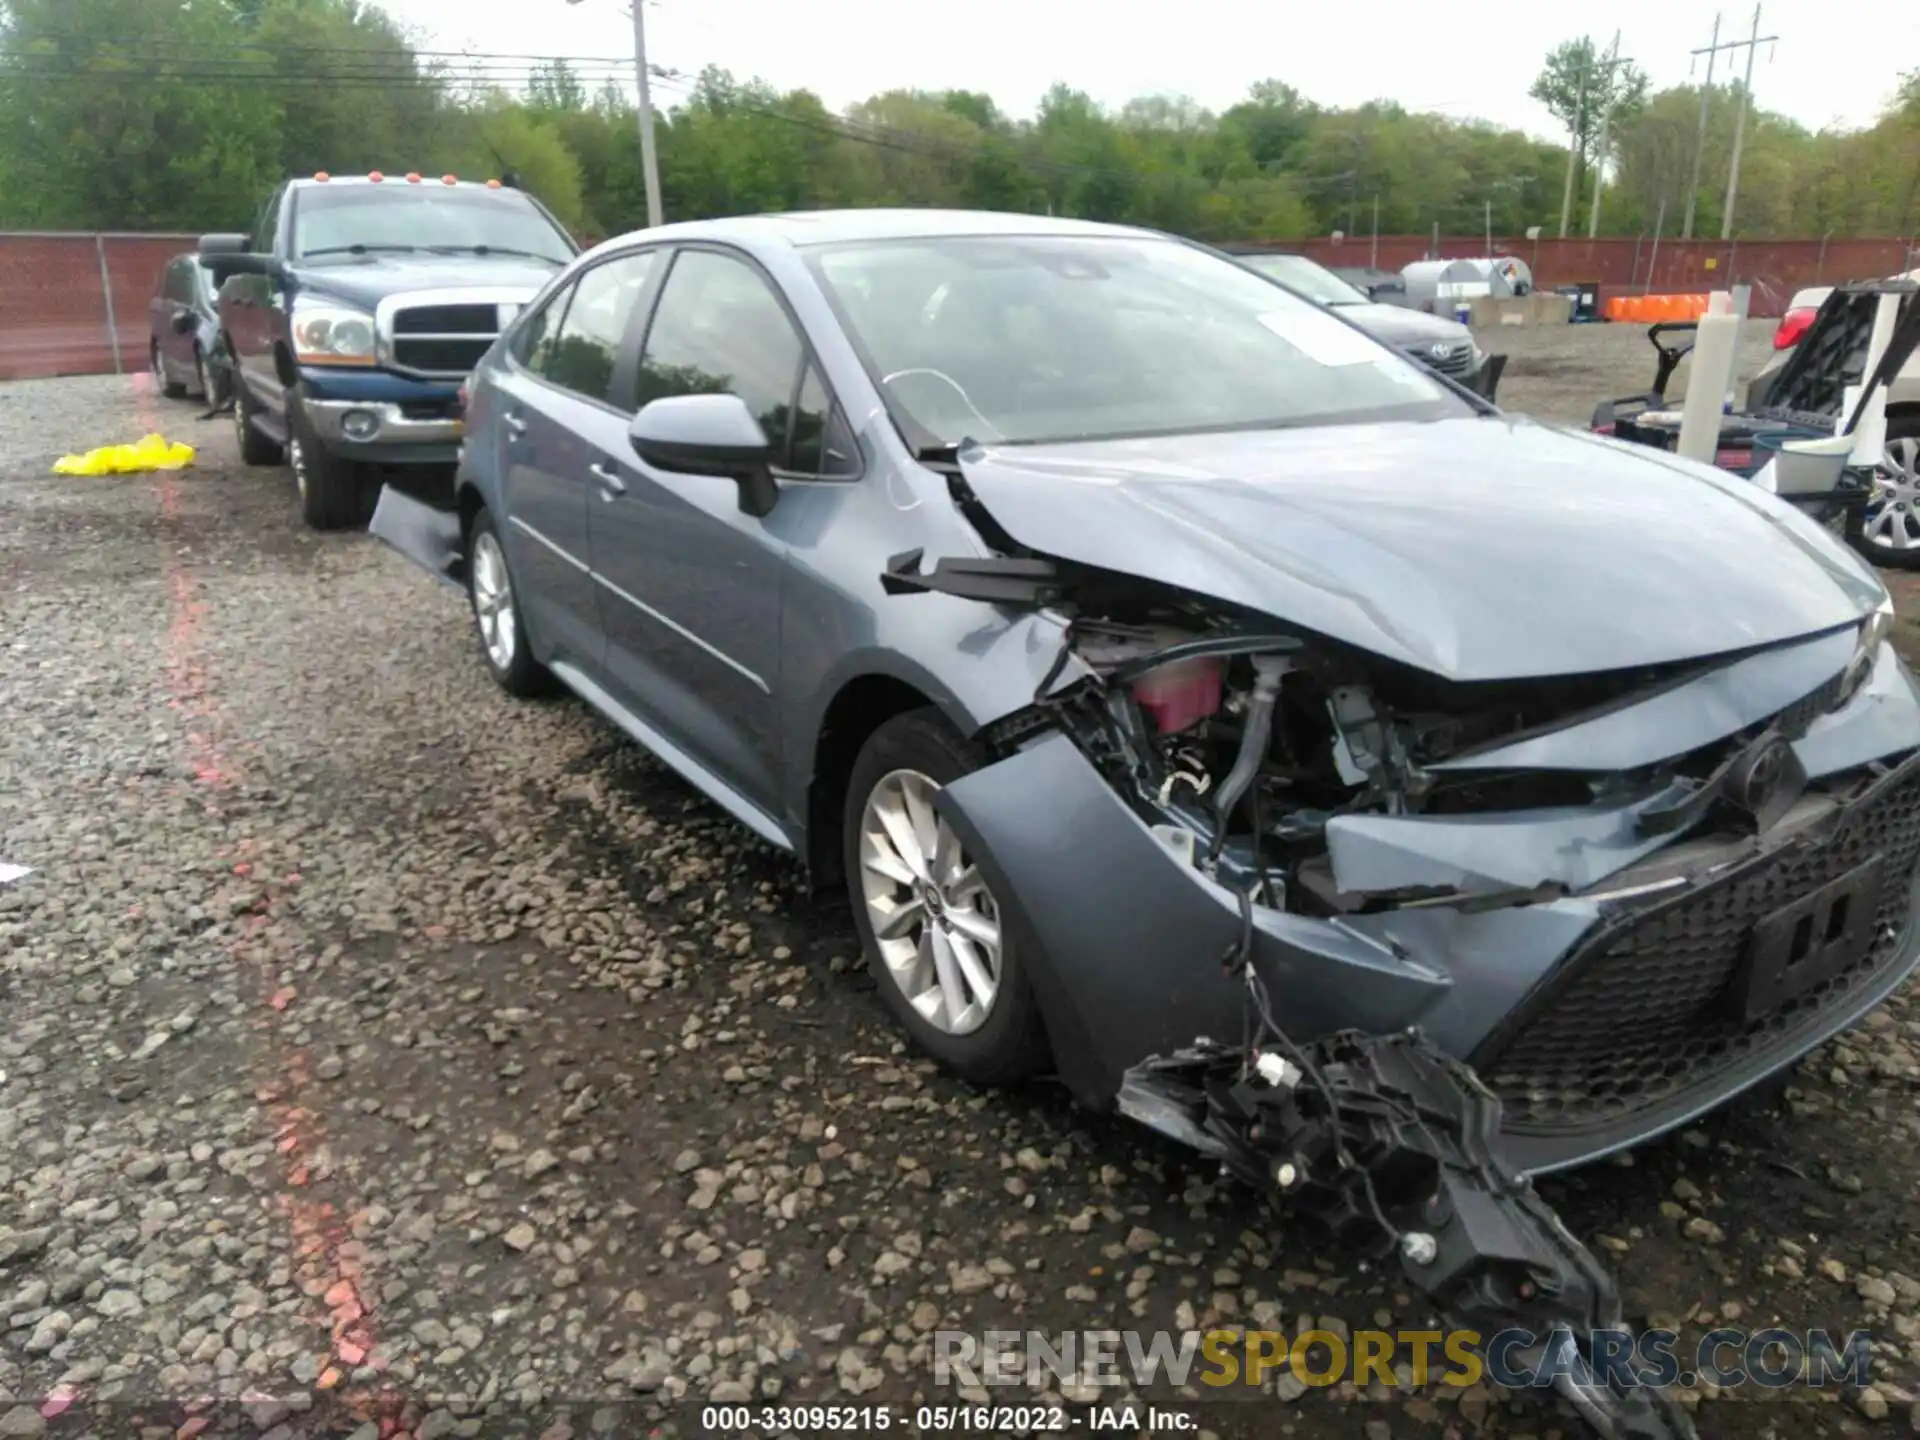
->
xmin=491 ymin=250 xmax=659 ymax=680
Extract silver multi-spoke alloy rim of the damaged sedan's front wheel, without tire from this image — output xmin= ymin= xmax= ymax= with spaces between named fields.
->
xmin=860 ymin=770 xmax=1000 ymax=1035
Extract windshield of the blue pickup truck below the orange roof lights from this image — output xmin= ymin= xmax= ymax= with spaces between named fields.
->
xmin=294 ymin=182 xmax=574 ymax=265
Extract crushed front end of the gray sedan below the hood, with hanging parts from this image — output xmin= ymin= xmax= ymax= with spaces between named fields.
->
xmin=906 ymin=557 xmax=1920 ymax=1436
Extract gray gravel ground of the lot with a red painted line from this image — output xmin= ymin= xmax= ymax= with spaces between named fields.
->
xmin=0 ymin=326 xmax=1920 ymax=1440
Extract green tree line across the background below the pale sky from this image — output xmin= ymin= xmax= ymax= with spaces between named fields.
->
xmin=0 ymin=0 xmax=1920 ymax=240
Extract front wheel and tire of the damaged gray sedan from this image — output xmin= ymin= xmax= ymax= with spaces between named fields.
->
xmin=843 ymin=708 xmax=1048 ymax=1083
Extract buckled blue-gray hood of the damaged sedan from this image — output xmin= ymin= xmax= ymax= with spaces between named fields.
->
xmin=960 ymin=417 xmax=1885 ymax=680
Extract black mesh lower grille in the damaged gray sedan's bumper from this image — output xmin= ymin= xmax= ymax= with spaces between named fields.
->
xmin=1473 ymin=758 xmax=1920 ymax=1137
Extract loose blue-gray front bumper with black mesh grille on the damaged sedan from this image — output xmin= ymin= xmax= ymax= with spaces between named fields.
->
xmin=939 ymin=733 xmax=1920 ymax=1173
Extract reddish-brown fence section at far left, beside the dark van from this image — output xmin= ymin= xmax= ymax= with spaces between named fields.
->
xmin=0 ymin=232 xmax=198 ymax=380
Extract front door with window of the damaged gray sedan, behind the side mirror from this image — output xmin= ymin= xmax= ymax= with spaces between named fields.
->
xmin=588 ymin=248 xmax=825 ymax=814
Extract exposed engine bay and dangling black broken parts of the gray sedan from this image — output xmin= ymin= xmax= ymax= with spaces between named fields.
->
xmin=887 ymin=533 xmax=1904 ymax=1440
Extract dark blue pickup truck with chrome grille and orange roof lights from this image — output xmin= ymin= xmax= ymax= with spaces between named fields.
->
xmin=200 ymin=171 xmax=578 ymax=530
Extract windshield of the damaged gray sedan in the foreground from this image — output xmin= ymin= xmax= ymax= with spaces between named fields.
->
xmin=808 ymin=236 xmax=1469 ymax=447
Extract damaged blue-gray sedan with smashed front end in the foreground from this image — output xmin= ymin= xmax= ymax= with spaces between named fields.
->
xmin=374 ymin=211 xmax=1920 ymax=1436
